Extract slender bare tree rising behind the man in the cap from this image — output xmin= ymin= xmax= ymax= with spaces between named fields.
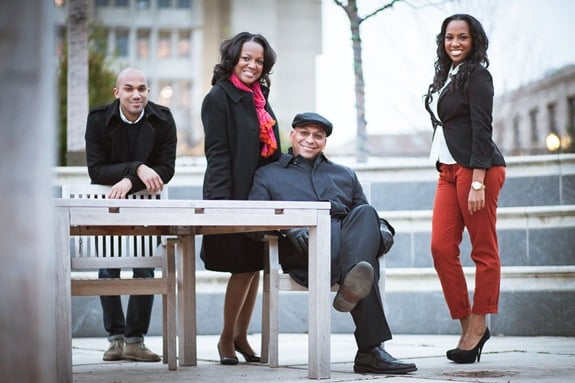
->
xmin=333 ymin=0 xmax=402 ymax=162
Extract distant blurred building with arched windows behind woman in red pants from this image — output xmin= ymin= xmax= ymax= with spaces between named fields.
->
xmin=352 ymin=65 xmax=575 ymax=157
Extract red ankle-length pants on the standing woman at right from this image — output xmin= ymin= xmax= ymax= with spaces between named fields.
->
xmin=431 ymin=164 xmax=505 ymax=319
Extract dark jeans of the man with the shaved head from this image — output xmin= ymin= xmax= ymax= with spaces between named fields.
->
xmin=98 ymin=268 xmax=154 ymax=343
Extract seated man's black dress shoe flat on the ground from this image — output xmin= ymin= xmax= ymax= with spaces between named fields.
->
xmin=353 ymin=345 xmax=417 ymax=374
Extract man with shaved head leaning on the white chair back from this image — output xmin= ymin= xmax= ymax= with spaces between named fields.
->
xmin=85 ymin=68 xmax=176 ymax=362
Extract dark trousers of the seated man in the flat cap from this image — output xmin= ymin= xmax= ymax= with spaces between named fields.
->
xmin=280 ymin=205 xmax=391 ymax=351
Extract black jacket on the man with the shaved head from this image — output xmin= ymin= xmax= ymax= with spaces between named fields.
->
xmin=85 ymin=100 xmax=177 ymax=193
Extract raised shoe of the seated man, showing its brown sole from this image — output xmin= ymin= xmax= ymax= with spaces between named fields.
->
xmin=333 ymin=261 xmax=373 ymax=313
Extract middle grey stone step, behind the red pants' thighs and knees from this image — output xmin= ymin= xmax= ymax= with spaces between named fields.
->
xmin=380 ymin=205 xmax=575 ymax=268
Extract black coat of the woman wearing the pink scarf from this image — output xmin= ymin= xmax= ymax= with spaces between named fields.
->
xmin=201 ymin=79 xmax=281 ymax=272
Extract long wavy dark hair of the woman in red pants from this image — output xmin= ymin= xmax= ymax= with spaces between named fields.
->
xmin=425 ymin=13 xmax=489 ymax=120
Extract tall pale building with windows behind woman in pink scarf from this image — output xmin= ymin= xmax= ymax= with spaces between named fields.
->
xmin=54 ymin=0 xmax=321 ymax=156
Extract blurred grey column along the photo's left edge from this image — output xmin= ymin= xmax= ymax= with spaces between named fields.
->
xmin=0 ymin=0 xmax=57 ymax=383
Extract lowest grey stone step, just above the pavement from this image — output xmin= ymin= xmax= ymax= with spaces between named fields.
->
xmin=72 ymin=266 xmax=575 ymax=337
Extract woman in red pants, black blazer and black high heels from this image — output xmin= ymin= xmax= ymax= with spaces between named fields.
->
xmin=425 ymin=14 xmax=505 ymax=363
